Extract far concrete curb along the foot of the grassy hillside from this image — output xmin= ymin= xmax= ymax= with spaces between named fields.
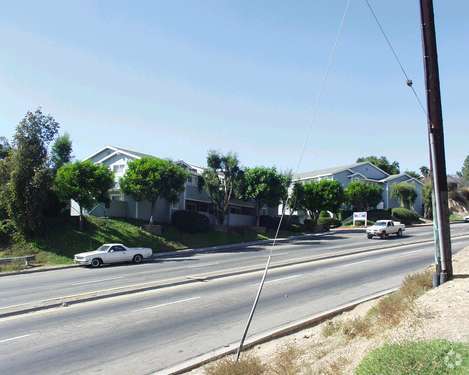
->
xmin=0 ymin=232 xmax=330 ymax=277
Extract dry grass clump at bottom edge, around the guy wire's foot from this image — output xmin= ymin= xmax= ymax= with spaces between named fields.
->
xmin=205 ymin=355 xmax=268 ymax=375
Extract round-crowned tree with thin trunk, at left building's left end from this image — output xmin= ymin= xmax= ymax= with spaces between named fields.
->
xmin=54 ymin=160 xmax=114 ymax=230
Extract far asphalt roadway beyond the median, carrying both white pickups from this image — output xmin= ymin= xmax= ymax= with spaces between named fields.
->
xmin=0 ymin=223 xmax=469 ymax=312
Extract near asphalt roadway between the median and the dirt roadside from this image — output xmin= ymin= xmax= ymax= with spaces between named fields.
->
xmin=0 ymin=229 xmax=469 ymax=374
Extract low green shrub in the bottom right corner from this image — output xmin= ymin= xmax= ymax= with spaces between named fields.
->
xmin=355 ymin=340 xmax=469 ymax=375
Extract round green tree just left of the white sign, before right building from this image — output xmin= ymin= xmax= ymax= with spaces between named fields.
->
xmin=303 ymin=180 xmax=344 ymax=223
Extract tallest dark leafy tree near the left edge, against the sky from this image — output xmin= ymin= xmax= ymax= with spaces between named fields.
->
xmin=8 ymin=109 xmax=59 ymax=235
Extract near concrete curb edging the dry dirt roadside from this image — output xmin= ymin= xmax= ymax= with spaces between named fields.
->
xmin=153 ymin=288 xmax=398 ymax=375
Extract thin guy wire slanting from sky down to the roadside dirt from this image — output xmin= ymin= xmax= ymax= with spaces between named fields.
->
xmin=236 ymin=0 xmax=351 ymax=361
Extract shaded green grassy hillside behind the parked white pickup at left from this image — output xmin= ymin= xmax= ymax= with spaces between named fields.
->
xmin=0 ymin=217 xmax=267 ymax=264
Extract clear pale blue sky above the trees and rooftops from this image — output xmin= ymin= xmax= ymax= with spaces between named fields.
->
xmin=0 ymin=0 xmax=469 ymax=173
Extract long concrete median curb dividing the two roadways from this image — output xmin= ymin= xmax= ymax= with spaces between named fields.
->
xmin=0 ymin=235 xmax=468 ymax=318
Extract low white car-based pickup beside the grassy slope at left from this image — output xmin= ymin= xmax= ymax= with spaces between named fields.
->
xmin=74 ymin=243 xmax=153 ymax=268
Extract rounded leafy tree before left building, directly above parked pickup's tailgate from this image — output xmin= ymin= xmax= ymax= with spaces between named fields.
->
xmin=120 ymin=157 xmax=188 ymax=224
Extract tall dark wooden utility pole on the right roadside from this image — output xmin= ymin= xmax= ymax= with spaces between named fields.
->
xmin=420 ymin=0 xmax=453 ymax=284
